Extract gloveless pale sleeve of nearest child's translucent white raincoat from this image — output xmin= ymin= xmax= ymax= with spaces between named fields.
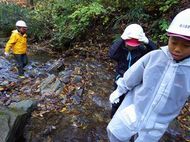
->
xmin=113 ymin=53 xmax=150 ymax=94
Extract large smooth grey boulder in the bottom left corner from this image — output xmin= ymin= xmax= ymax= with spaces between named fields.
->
xmin=0 ymin=100 xmax=35 ymax=142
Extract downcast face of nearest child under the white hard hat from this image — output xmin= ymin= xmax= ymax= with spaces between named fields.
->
xmin=168 ymin=36 xmax=190 ymax=61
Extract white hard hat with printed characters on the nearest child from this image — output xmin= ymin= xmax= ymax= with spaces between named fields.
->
xmin=166 ymin=8 xmax=190 ymax=37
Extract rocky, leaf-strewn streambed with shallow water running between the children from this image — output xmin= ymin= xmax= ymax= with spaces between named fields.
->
xmin=0 ymin=44 xmax=189 ymax=142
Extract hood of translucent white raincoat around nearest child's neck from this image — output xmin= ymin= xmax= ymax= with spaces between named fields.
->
xmin=161 ymin=46 xmax=190 ymax=66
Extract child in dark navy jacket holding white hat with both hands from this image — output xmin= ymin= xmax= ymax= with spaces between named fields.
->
xmin=109 ymin=24 xmax=157 ymax=117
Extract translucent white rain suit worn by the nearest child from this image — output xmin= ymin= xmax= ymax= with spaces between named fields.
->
xmin=107 ymin=46 xmax=190 ymax=142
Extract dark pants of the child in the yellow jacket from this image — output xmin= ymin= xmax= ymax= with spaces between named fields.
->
xmin=14 ymin=54 xmax=28 ymax=75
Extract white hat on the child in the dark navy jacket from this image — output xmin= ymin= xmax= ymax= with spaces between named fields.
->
xmin=121 ymin=24 xmax=145 ymax=40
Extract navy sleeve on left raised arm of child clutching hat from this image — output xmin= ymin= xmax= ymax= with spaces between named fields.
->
xmin=109 ymin=38 xmax=123 ymax=61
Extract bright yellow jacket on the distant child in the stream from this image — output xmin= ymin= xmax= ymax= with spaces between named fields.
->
xmin=5 ymin=30 xmax=27 ymax=54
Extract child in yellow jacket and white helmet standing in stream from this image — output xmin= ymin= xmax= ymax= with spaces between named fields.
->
xmin=4 ymin=20 xmax=28 ymax=78
